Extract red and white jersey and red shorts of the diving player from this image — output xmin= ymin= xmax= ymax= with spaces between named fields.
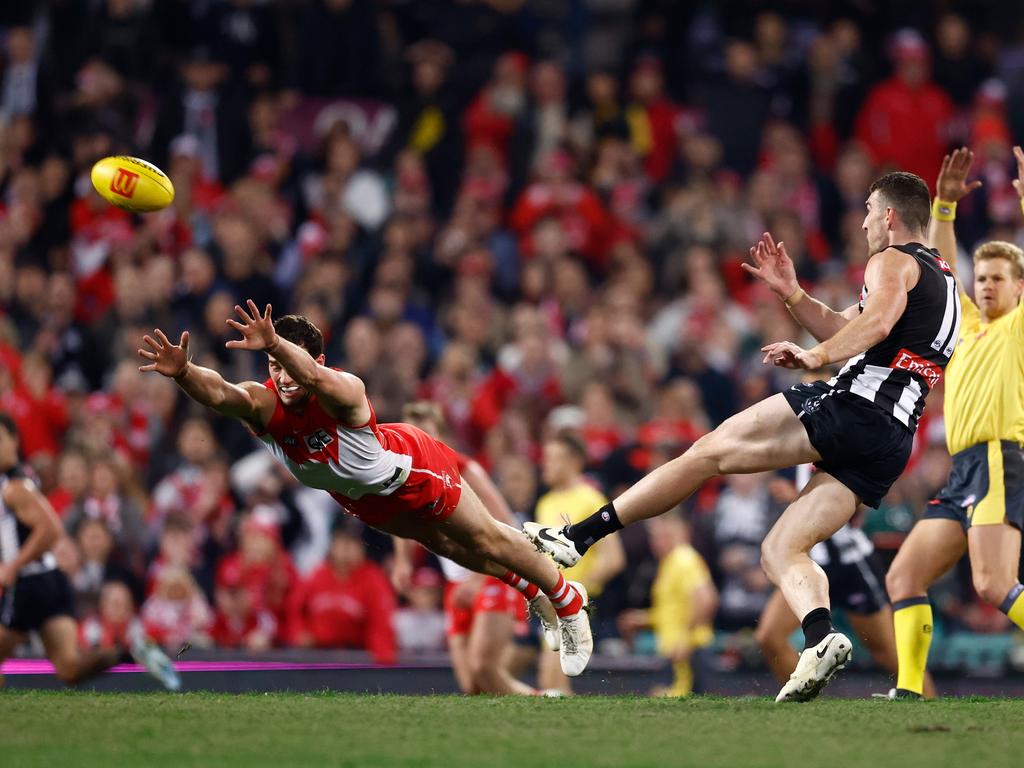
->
xmin=256 ymin=379 xmax=462 ymax=524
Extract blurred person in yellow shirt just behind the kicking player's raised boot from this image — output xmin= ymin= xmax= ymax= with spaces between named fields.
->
xmin=535 ymin=432 xmax=626 ymax=693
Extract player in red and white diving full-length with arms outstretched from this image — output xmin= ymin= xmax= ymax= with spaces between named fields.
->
xmin=138 ymin=300 xmax=594 ymax=676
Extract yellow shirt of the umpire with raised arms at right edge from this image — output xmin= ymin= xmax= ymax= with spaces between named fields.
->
xmin=944 ymin=292 xmax=1024 ymax=455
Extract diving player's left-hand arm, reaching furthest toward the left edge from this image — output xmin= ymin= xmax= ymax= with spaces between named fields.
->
xmin=138 ymin=328 xmax=276 ymax=431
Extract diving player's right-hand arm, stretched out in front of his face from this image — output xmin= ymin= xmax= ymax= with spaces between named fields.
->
xmin=225 ymin=299 xmax=370 ymax=427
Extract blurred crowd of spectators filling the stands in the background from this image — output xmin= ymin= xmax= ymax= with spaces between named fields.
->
xmin=0 ymin=0 xmax=1024 ymax=662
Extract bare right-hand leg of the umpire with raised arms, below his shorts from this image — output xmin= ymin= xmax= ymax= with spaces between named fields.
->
xmin=967 ymin=524 xmax=1024 ymax=630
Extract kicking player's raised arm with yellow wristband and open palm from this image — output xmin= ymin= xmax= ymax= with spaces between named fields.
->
xmin=742 ymin=232 xmax=857 ymax=341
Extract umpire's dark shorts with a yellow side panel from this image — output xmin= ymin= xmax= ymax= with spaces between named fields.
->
xmin=923 ymin=440 xmax=1024 ymax=531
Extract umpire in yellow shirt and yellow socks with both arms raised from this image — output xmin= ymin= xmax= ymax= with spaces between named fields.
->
xmin=886 ymin=146 xmax=1024 ymax=697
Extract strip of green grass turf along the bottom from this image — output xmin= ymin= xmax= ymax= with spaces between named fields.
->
xmin=0 ymin=690 xmax=1024 ymax=768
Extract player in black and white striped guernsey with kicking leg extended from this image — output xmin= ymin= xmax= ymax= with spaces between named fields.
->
xmin=525 ymin=173 xmax=961 ymax=701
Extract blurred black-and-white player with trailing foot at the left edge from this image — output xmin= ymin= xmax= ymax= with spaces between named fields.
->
xmin=0 ymin=413 xmax=180 ymax=689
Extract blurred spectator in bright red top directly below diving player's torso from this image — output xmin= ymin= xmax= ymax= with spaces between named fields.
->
xmin=289 ymin=520 xmax=395 ymax=664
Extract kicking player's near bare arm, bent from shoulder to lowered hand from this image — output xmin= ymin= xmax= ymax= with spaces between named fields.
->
xmin=761 ymin=248 xmax=921 ymax=370
